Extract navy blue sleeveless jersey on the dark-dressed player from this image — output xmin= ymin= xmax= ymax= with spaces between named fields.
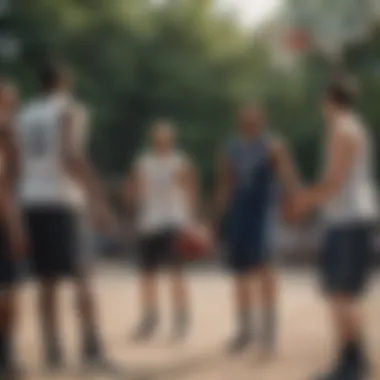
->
xmin=227 ymin=136 xmax=276 ymax=255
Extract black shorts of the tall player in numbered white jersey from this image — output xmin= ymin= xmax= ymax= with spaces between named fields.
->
xmin=25 ymin=205 xmax=80 ymax=279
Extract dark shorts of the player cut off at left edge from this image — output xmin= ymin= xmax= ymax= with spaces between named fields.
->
xmin=0 ymin=226 xmax=20 ymax=290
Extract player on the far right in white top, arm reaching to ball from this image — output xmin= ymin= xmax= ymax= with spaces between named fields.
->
xmin=294 ymin=80 xmax=378 ymax=380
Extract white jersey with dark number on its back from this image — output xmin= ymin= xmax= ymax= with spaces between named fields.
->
xmin=17 ymin=95 xmax=78 ymax=205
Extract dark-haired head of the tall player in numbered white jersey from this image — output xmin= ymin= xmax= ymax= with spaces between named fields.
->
xmin=39 ymin=63 xmax=70 ymax=93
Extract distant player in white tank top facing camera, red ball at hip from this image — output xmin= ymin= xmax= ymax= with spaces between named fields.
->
xmin=129 ymin=121 xmax=196 ymax=340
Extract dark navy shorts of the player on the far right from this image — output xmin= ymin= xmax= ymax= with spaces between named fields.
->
xmin=319 ymin=223 xmax=374 ymax=296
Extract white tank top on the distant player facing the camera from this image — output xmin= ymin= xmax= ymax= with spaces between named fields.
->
xmin=137 ymin=152 xmax=190 ymax=232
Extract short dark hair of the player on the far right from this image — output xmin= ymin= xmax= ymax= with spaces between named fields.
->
xmin=326 ymin=78 xmax=358 ymax=108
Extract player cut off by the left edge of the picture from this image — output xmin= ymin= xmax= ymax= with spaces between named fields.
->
xmin=0 ymin=80 xmax=25 ymax=379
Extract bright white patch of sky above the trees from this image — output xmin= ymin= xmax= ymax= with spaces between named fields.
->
xmin=217 ymin=0 xmax=283 ymax=27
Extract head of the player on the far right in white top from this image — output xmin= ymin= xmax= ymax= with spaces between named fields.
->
xmin=322 ymin=80 xmax=357 ymax=121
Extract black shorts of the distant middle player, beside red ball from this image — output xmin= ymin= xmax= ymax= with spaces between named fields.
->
xmin=138 ymin=229 xmax=182 ymax=271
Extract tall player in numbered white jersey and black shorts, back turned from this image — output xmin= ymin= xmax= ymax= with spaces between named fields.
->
xmin=18 ymin=64 xmax=109 ymax=369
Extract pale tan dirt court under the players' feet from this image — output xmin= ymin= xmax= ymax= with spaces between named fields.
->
xmin=18 ymin=267 xmax=380 ymax=380
